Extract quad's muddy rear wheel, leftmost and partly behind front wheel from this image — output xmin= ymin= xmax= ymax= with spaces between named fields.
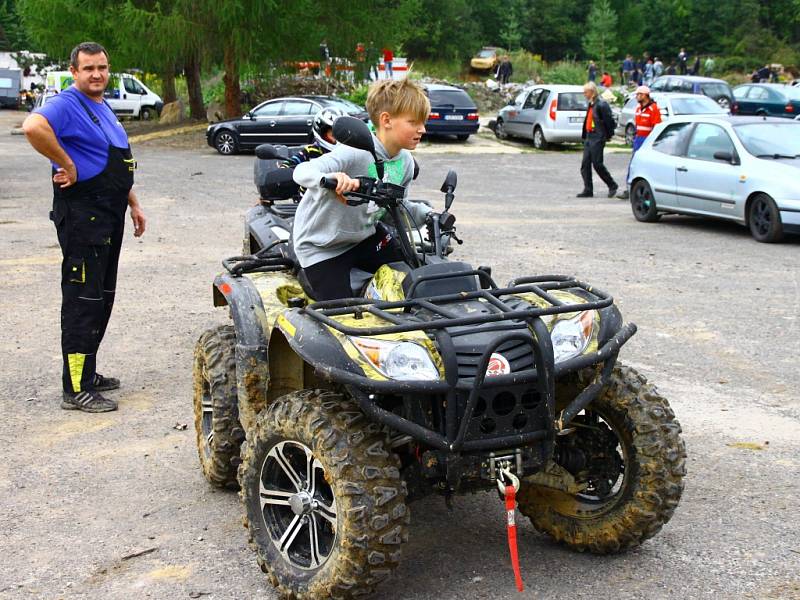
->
xmin=194 ymin=325 xmax=245 ymax=490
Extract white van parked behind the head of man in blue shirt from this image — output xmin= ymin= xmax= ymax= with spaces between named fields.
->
xmin=46 ymin=71 xmax=164 ymax=121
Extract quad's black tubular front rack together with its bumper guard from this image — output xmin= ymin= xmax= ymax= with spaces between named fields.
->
xmin=301 ymin=270 xmax=636 ymax=452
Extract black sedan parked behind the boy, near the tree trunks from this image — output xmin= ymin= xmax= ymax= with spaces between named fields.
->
xmin=206 ymin=96 xmax=369 ymax=155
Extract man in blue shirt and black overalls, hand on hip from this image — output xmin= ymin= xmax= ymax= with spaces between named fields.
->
xmin=22 ymin=42 xmax=146 ymax=412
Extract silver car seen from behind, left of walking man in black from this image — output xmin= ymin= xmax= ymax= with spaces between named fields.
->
xmin=494 ymin=85 xmax=588 ymax=150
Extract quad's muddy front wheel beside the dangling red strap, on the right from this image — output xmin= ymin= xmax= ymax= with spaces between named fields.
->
xmin=519 ymin=366 xmax=686 ymax=554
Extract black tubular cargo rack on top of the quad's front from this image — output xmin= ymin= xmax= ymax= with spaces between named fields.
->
xmin=302 ymin=270 xmax=614 ymax=336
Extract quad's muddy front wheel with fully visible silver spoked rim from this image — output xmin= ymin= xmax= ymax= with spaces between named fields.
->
xmin=239 ymin=390 xmax=410 ymax=600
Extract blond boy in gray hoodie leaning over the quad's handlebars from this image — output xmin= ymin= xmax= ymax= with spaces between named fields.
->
xmin=293 ymin=80 xmax=431 ymax=300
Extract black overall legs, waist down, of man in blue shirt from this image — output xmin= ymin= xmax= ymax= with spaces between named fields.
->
xmin=52 ymin=193 xmax=127 ymax=393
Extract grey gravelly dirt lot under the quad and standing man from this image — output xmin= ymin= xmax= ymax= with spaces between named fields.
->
xmin=0 ymin=112 xmax=800 ymax=600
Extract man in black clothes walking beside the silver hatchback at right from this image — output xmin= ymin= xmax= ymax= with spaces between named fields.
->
xmin=577 ymin=81 xmax=619 ymax=198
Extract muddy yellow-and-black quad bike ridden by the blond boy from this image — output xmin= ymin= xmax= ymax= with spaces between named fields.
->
xmin=194 ymin=117 xmax=686 ymax=598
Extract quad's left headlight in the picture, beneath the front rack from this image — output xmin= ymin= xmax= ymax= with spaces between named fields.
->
xmin=350 ymin=337 xmax=439 ymax=381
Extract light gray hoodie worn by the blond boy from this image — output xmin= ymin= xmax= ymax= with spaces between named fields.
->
xmin=292 ymin=135 xmax=431 ymax=268
